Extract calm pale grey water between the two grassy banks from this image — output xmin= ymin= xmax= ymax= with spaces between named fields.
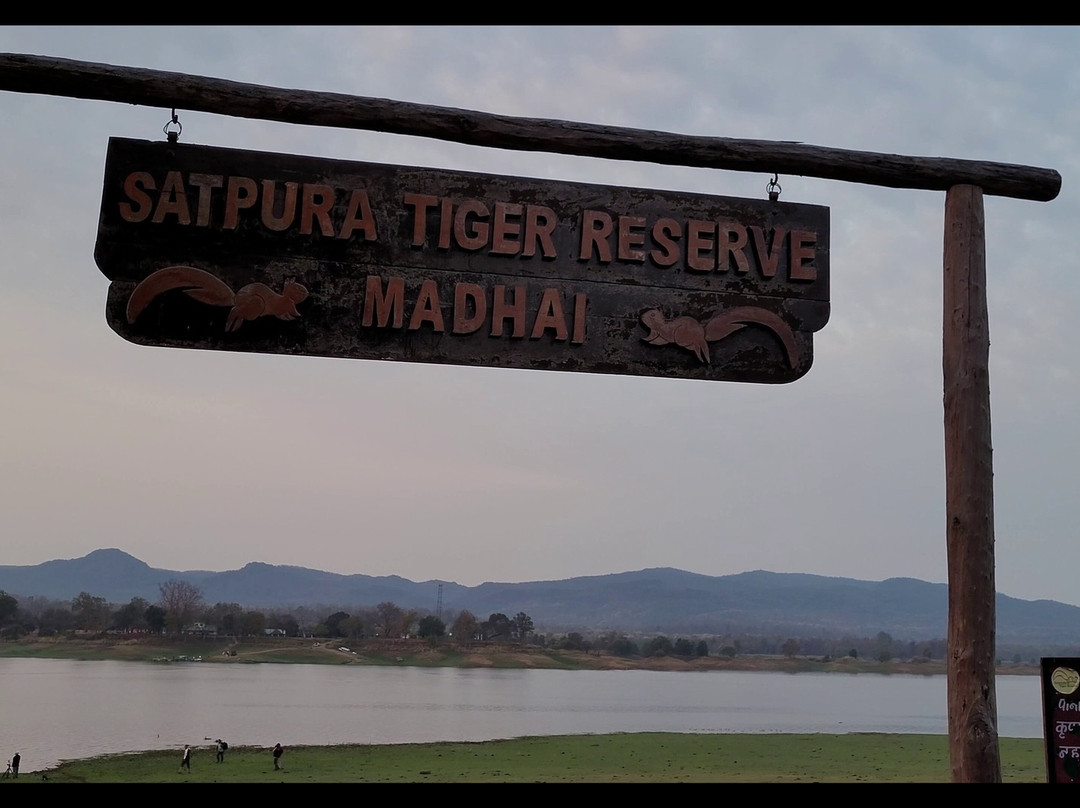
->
xmin=0 ymin=659 xmax=1042 ymax=771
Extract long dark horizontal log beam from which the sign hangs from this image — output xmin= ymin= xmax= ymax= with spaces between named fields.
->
xmin=0 ymin=53 xmax=1062 ymax=201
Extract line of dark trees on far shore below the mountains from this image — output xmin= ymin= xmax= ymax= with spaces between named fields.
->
xmin=0 ymin=580 xmax=1054 ymax=663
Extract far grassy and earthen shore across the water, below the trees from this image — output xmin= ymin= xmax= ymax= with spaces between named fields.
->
xmin=0 ymin=636 xmax=1038 ymax=675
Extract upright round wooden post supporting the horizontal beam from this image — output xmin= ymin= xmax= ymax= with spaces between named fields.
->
xmin=942 ymin=185 xmax=1001 ymax=782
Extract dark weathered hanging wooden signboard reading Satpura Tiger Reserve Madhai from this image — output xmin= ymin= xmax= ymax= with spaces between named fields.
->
xmin=95 ymin=138 xmax=829 ymax=382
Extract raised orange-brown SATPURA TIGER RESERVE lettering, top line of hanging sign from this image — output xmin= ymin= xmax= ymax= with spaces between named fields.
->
xmin=119 ymin=171 xmax=818 ymax=283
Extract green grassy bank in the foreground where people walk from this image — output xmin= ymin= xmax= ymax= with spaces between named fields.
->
xmin=4 ymin=732 xmax=1045 ymax=785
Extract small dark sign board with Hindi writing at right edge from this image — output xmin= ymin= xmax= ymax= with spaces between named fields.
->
xmin=1041 ymin=657 xmax=1080 ymax=783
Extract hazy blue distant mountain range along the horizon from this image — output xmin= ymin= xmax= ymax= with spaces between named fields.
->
xmin=0 ymin=550 xmax=1080 ymax=645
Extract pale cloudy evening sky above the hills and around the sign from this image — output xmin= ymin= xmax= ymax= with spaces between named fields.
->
xmin=0 ymin=26 xmax=1080 ymax=604
